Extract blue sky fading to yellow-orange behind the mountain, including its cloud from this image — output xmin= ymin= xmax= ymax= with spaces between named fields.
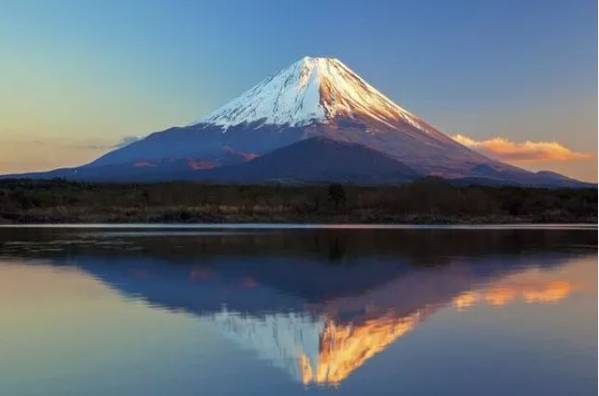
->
xmin=0 ymin=0 xmax=597 ymax=181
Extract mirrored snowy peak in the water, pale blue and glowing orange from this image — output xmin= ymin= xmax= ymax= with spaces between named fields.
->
xmin=202 ymin=309 xmax=426 ymax=385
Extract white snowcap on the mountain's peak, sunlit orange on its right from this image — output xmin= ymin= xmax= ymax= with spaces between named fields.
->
xmin=199 ymin=57 xmax=430 ymax=131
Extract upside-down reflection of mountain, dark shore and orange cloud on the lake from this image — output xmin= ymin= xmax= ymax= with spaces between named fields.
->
xmin=0 ymin=226 xmax=596 ymax=385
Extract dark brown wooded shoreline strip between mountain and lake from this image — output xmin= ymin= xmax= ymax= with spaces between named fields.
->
xmin=0 ymin=180 xmax=597 ymax=225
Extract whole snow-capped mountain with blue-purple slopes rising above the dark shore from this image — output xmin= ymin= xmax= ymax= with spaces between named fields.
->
xmin=2 ymin=57 xmax=592 ymax=186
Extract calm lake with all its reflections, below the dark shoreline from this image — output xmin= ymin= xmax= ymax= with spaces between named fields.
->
xmin=0 ymin=225 xmax=597 ymax=396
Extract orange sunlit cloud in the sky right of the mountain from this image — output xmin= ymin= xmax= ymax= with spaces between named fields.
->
xmin=453 ymin=134 xmax=592 ymax=161
